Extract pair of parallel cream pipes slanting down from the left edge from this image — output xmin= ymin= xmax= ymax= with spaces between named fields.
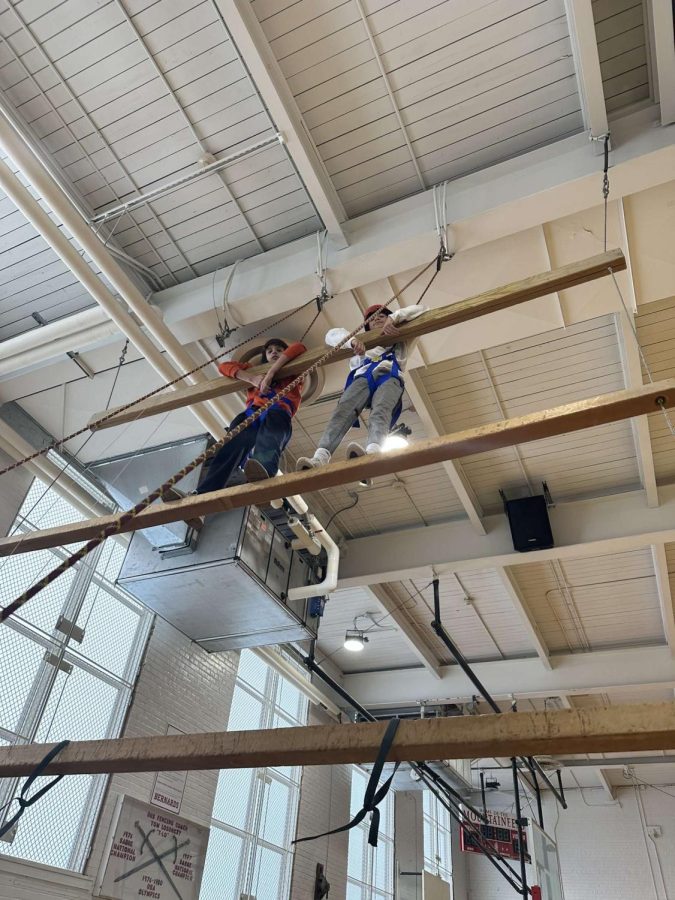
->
xmin=0 ymin=117 xmax=226 ymax=438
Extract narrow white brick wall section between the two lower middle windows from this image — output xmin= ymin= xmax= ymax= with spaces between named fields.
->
xmin=291 ymin=706 xmax=352 ymax=900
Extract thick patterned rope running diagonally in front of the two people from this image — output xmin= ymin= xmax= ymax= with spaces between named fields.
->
xmin=0 ymin=258 xmax=440 ymax=623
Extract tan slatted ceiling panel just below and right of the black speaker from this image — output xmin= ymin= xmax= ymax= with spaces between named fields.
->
xmin=512 ymin=550 xmax=664 ymax=652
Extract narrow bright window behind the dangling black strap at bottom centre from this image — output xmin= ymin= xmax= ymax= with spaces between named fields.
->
xmin=347 ymin=766 xmax=394 ymax=900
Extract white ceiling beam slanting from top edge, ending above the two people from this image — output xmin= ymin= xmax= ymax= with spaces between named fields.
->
xmin=215 ymin=0 xmax=348 ymax=248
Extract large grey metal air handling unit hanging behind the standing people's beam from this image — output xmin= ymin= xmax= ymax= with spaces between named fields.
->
xmin=92 ymin=440 xmax=325 ymax=651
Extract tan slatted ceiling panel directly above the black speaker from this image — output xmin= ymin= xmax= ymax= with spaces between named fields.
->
xmin=423 ymin=317 xmax=639 ymax=510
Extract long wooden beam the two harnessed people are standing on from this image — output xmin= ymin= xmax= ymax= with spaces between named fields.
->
xmin=0 ymin=378 xmax=675 ymax=556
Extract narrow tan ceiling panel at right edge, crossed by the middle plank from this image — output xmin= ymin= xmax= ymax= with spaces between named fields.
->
xmin=636 ymin=297 xmax=675 ymax=483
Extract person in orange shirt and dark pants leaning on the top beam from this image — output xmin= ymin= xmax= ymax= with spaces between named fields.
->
xmin=197 ymin=338 xmax=307 ymax=494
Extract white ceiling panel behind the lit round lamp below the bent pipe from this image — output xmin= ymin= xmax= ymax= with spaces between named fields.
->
xmin=317 ymin=588 xmax=421 ymax=672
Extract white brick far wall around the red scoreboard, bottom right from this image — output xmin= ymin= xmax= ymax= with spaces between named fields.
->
xmin=468 ymin=786 xmax=675 ymax=900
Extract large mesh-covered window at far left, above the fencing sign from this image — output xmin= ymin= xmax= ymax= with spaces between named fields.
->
xmin=0 ymin=481 xmax=152 ymax=871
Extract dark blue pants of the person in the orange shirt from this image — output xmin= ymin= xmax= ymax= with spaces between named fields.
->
xmin=197 ymin=407 xmax=293 ymax=494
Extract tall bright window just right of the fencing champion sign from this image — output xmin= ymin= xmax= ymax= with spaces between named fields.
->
xmin=199 ymin=650 xmax=307 ymax=900
